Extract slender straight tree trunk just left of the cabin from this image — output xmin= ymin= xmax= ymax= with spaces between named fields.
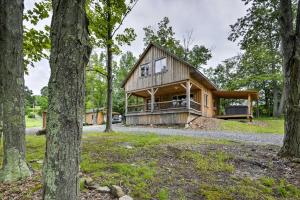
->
xmin=105 ymin=0 xmax=113 ymax=132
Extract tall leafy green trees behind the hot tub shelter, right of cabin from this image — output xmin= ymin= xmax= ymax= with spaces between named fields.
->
xmin=206 ymin=0 xmax=292 ymax=116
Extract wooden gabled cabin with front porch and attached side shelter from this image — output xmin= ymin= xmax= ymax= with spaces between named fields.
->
xmin=122 ymin=43 xmax=258 ymax=125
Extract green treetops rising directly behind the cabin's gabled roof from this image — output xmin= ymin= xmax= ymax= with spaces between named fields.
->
xmin=144 ymin=17 xmax=212 ymax=69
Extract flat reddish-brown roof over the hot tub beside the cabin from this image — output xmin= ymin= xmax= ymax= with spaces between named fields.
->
xmin=213 ymin=90 xmax=258 ymax=100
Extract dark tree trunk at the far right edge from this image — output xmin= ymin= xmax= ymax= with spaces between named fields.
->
xmin=279 ymin=0 xmax=300 ymax=158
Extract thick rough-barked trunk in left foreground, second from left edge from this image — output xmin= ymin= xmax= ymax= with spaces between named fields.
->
xmin=43 ymin=0 xmax=91 ymax=200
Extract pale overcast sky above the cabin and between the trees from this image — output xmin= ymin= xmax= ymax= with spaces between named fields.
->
xmin=25 ymin=0 xmax=246 ymax=94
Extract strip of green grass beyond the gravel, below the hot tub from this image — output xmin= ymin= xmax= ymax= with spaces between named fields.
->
xmin=220 ymin=118 xmax=284 ymax=134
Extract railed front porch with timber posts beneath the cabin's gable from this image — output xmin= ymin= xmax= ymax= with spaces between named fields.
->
xmin=125 ymin=80 xmax=202 ymax=124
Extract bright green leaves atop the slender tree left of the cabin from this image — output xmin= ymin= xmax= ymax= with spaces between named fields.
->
xmin=86 ymin=0 xmax=137 ymax=54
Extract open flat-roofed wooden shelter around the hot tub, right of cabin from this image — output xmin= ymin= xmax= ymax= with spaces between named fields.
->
xmin=213 ymin=91 xmax=258 ymax=121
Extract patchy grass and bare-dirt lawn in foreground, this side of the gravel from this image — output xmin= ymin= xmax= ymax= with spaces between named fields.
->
xmin=0 ymin=133 xmax=300 ymax=200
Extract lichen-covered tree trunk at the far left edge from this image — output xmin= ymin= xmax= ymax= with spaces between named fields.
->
xmin=0 ymin=0 xmax=31 ymax=181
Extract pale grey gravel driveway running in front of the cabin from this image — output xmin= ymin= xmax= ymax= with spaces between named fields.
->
xmin=26 ymin=124 xmax=283 ymax=145
